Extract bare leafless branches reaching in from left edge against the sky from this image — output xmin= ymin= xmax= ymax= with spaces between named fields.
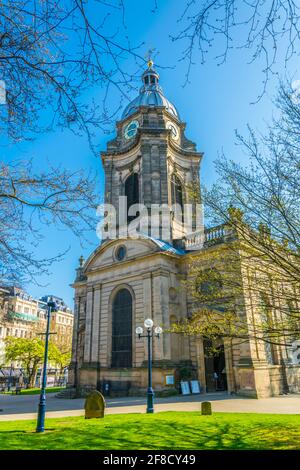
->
xmin=0 ymin=0 xmax=151 ymax=284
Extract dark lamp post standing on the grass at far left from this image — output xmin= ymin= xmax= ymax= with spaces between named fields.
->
xmin=36 ymin=297 xmax=58 ymax=432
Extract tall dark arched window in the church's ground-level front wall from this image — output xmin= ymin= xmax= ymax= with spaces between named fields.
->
xmin=111 ymin=289 xmax=132 ymax=367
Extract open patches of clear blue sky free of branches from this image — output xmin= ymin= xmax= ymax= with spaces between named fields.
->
xmin=2 ymin=0 xmax=299 ymax=306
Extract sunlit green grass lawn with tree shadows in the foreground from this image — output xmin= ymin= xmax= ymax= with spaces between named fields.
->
xmin=0 ymin=412 xmax=300 ymax=450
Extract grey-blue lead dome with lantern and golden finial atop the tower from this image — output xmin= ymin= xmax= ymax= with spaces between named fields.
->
xmin=122 ymin=60 xmax=179 ymax=119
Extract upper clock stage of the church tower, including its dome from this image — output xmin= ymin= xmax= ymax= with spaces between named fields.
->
xmin=102 ymin=61 xmax=202 ymax=246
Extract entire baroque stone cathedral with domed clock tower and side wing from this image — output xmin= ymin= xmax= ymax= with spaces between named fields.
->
xmin=69 ymin=61 xmax=299 ymax=398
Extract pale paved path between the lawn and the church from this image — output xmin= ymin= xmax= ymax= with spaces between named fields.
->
xmin=0 ymin=393 xmax=300 ymax=421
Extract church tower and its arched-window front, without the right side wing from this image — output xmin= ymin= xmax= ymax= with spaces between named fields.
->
xmin=70 ymin=61 xmax=202 ymax=393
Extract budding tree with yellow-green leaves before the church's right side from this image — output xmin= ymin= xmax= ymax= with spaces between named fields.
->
xmin=170 ymin=84 xmax=300 ymax=354
